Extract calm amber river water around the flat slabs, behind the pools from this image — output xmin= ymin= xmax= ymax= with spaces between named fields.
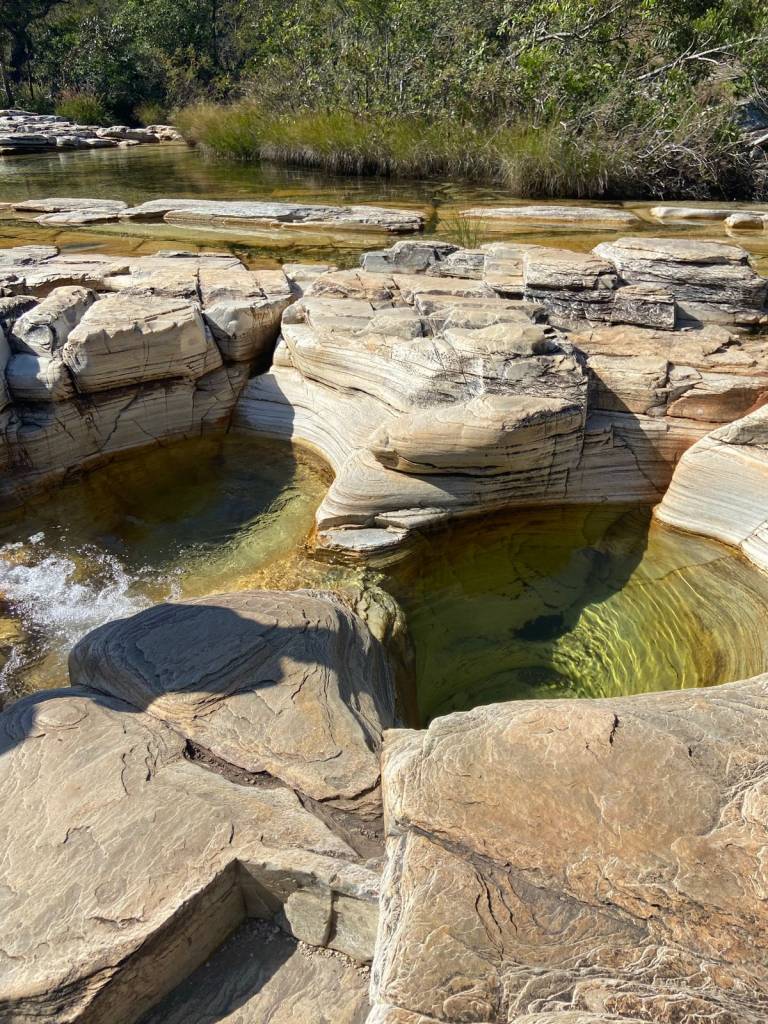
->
xmin=0 ymin=145 xmax=768 ymax=273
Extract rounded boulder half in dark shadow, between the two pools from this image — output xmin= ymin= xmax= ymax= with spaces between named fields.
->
xmin=70 ymin=591 xmax=394 ymax=814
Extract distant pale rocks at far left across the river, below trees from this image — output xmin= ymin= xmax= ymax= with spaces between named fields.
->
xmin=0 ymin=109 xmax=183 ymax=156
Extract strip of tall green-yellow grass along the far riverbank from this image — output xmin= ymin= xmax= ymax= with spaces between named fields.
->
xmin=176 ymin=99 xmax=749 ymax=199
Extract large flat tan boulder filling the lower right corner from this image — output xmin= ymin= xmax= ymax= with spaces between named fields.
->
xmin=372 ymin=677 xmax=768 ymax=1024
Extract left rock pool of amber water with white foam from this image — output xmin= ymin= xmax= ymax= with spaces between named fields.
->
xmin=0 ymin=434 xmax=328 ymax=695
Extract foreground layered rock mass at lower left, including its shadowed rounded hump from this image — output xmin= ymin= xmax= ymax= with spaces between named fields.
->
xmin=0 ymin=592 xmax=394 ymax=1024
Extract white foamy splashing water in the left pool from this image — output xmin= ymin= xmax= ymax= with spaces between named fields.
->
xmin=0 ymin=534 xmax=158 ymax=690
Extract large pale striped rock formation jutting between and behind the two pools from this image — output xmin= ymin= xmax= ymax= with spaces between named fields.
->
xmin=237 ymin=238 xmax=768 ymax=555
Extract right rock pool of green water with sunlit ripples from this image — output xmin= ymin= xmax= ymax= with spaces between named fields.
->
xmin=390 ymin=506 xmax=768 ymax=722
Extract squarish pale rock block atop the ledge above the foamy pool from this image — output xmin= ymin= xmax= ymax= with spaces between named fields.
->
xmin=61 ymin=294 xmax=221 ymax=393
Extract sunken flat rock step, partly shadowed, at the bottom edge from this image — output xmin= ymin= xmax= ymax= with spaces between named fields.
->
xmin=141 ymin=922 xmax=369 ymax=1024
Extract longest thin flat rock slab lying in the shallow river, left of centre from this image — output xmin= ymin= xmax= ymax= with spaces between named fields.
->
xmin=120 ymin=199 xmax=424 ymax=234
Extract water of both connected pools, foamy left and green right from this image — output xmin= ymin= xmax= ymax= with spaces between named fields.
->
xmin=0 ymin=434 xmax=768 ymax=723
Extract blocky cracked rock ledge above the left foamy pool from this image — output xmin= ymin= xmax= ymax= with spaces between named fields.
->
xmin=0 ymin=246 xmax=293 ymax=501
